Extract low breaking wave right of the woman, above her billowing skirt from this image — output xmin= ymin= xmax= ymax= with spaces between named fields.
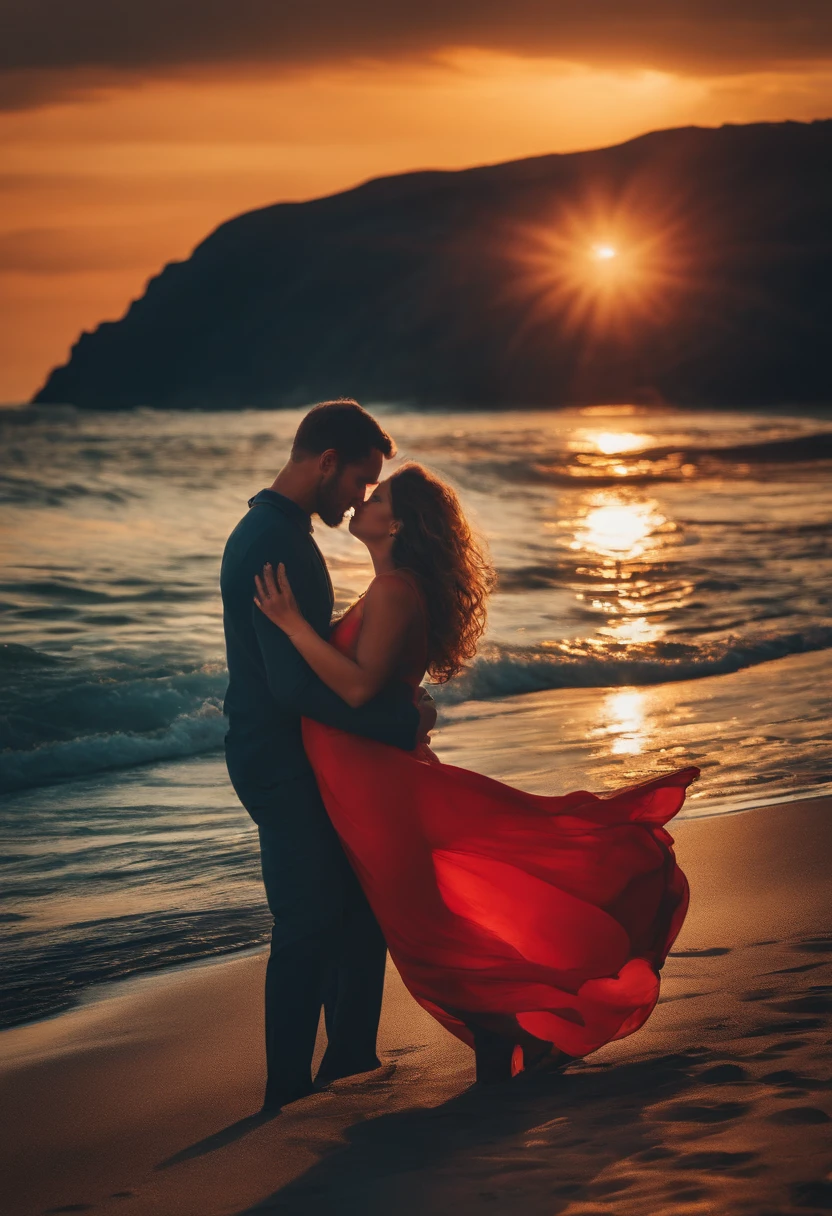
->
xmin=434 ymin=626 xmax=832 ymax=705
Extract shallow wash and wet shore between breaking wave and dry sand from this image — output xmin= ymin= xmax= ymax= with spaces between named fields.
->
xmin=0 ymin=651 xmax=832 ymax=1026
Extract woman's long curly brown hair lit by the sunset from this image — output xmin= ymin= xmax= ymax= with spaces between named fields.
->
xmin=389 ymin=463 xmax=496 ymax=683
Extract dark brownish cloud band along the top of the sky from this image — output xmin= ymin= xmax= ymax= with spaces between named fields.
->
xmin=0 ymin=0 xmax=832 ymax=108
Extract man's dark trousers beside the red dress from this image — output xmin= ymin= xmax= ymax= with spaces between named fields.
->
xmin=257 ymin=783 xmax=387 ymax=1105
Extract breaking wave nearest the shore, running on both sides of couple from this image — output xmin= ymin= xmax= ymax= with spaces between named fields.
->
xmin=0 ymin=626 xmax=832 ymax=792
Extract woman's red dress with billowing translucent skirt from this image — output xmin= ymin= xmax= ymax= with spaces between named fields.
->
xmin=303 ymin=574 xmax=698 ymax=1055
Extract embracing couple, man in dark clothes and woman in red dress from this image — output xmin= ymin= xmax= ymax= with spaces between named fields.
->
xmin=221 ymin=400 xmax=698 ymax=1111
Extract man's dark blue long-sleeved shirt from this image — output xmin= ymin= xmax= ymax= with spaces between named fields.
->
xmin=220 ymin=490 xmax=418 ymax=818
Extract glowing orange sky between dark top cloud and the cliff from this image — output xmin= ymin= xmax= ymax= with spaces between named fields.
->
xmin=0 ymin=26 xmax=832 ymax=401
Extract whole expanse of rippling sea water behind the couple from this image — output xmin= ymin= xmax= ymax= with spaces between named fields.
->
xmin=0 ymin=407 xmax=832 ymax=1025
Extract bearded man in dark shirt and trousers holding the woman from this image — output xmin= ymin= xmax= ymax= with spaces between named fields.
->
xmin=220 ymin=400 xmax=435 ymax=1113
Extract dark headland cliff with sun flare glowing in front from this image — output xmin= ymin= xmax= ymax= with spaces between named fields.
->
xmin=34 ymin=120 xmax=832 ymax=409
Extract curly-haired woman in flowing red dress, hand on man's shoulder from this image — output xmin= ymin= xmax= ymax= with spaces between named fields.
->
xmin=254 ymin=465 xmax=698 ymax=1081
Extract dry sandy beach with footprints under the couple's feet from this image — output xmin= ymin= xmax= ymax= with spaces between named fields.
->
xmin=0 ymin=799 xmax=832 ymax=1216
